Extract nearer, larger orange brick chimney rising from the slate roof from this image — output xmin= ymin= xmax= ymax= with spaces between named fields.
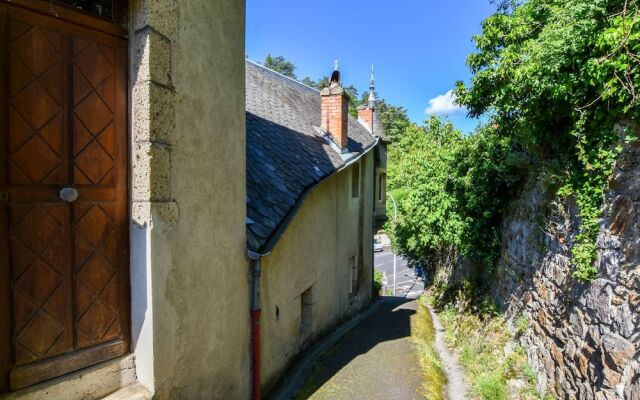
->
xmin=320 ymin=64 xmax=349 ymax=153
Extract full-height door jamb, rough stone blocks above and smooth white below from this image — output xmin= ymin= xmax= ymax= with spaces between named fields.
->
xmin=129 ymin=0 xmax=179 ymax=392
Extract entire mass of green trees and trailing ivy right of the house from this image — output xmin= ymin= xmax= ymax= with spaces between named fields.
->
xmin=389 ymin=0 xmax=640 ymax=281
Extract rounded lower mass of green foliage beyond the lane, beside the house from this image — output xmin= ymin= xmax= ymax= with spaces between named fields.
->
xmin=389 ymin=117 xmax=526 ymax=267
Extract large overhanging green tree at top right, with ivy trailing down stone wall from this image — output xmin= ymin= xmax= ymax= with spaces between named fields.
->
xmin=456 ymin=0 xmax=640 ymax=280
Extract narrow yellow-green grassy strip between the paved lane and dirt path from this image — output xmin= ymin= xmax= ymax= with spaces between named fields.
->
xmin=411 ymin=299 xmax=447 ymax=400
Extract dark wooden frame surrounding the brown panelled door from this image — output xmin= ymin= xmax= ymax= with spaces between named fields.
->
xmin=0 ymin=0 xmax=131 ymax=394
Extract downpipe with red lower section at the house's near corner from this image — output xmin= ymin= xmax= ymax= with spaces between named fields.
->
xmin=248 ymin=251 xmax=262 ymax=400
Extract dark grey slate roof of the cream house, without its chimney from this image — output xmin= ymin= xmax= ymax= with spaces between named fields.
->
xmin=245 ymin=61 xmax=376 ymax=252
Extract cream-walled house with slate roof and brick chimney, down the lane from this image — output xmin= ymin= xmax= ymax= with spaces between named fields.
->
xmin=246 ymin=61 xmax=380 ymax=396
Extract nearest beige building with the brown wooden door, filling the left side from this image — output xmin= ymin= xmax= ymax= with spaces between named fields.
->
xmin=0 ymin=0 xmax=250 ymax=399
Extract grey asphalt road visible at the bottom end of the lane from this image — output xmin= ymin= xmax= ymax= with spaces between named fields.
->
xmin=373 ymin=250 xmax=424 ymax=298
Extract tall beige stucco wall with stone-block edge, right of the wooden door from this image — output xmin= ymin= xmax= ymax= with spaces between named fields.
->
xmin=132 ymin=0 xmax=249 ymax=399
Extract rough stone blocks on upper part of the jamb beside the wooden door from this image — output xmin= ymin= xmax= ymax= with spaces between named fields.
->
xmin=130 ymin=0 xmax=178 ymax=226
